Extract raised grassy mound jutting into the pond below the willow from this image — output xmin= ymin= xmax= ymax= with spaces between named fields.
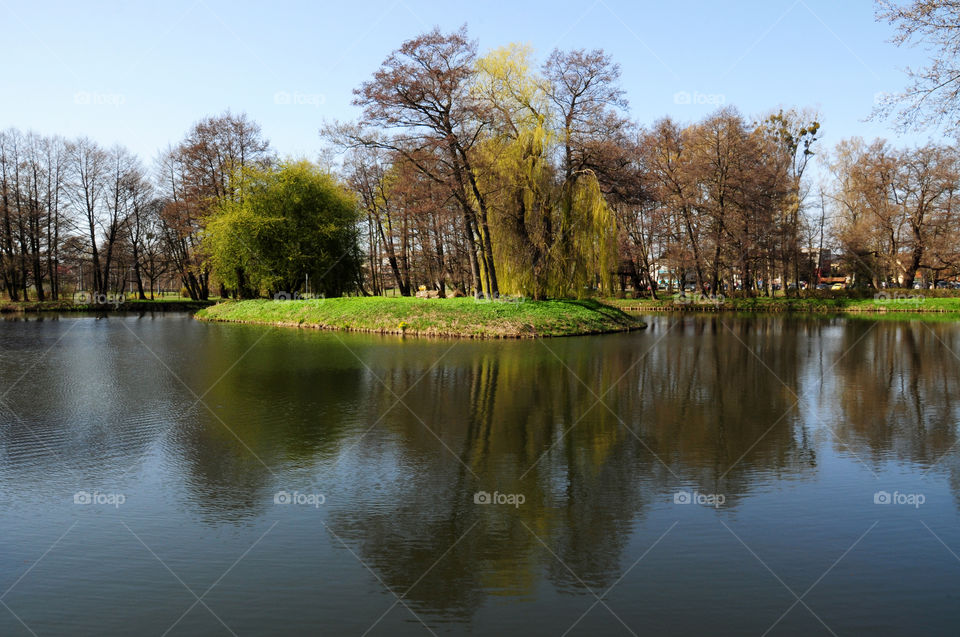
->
xmin=196 ymin=297 xmax=644 ymax=338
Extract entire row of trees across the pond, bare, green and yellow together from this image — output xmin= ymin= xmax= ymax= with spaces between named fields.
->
xmin=0 ymin=17 xmax=960 ymax=300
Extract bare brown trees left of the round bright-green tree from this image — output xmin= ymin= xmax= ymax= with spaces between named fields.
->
xmin=0 ymin=113 xmax=268 ymax=301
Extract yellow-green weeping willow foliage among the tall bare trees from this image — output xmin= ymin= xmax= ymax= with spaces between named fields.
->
xmin=475 ymin=44 xmax=616 ymax=298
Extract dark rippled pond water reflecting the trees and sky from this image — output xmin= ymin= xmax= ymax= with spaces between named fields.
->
xmin=0 ymin=315 xmax=960 ymax=637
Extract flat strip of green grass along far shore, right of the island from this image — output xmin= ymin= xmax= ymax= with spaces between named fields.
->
xmin=604 ymin=290 xmax=960 ymax=318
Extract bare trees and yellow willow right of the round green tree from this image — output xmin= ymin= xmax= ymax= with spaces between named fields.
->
xmin=332 ymin=27 xmax=957 ymax=298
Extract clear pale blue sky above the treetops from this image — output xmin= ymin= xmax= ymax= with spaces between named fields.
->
xmin=0 ymin=0 xmax=940 ymax=162
